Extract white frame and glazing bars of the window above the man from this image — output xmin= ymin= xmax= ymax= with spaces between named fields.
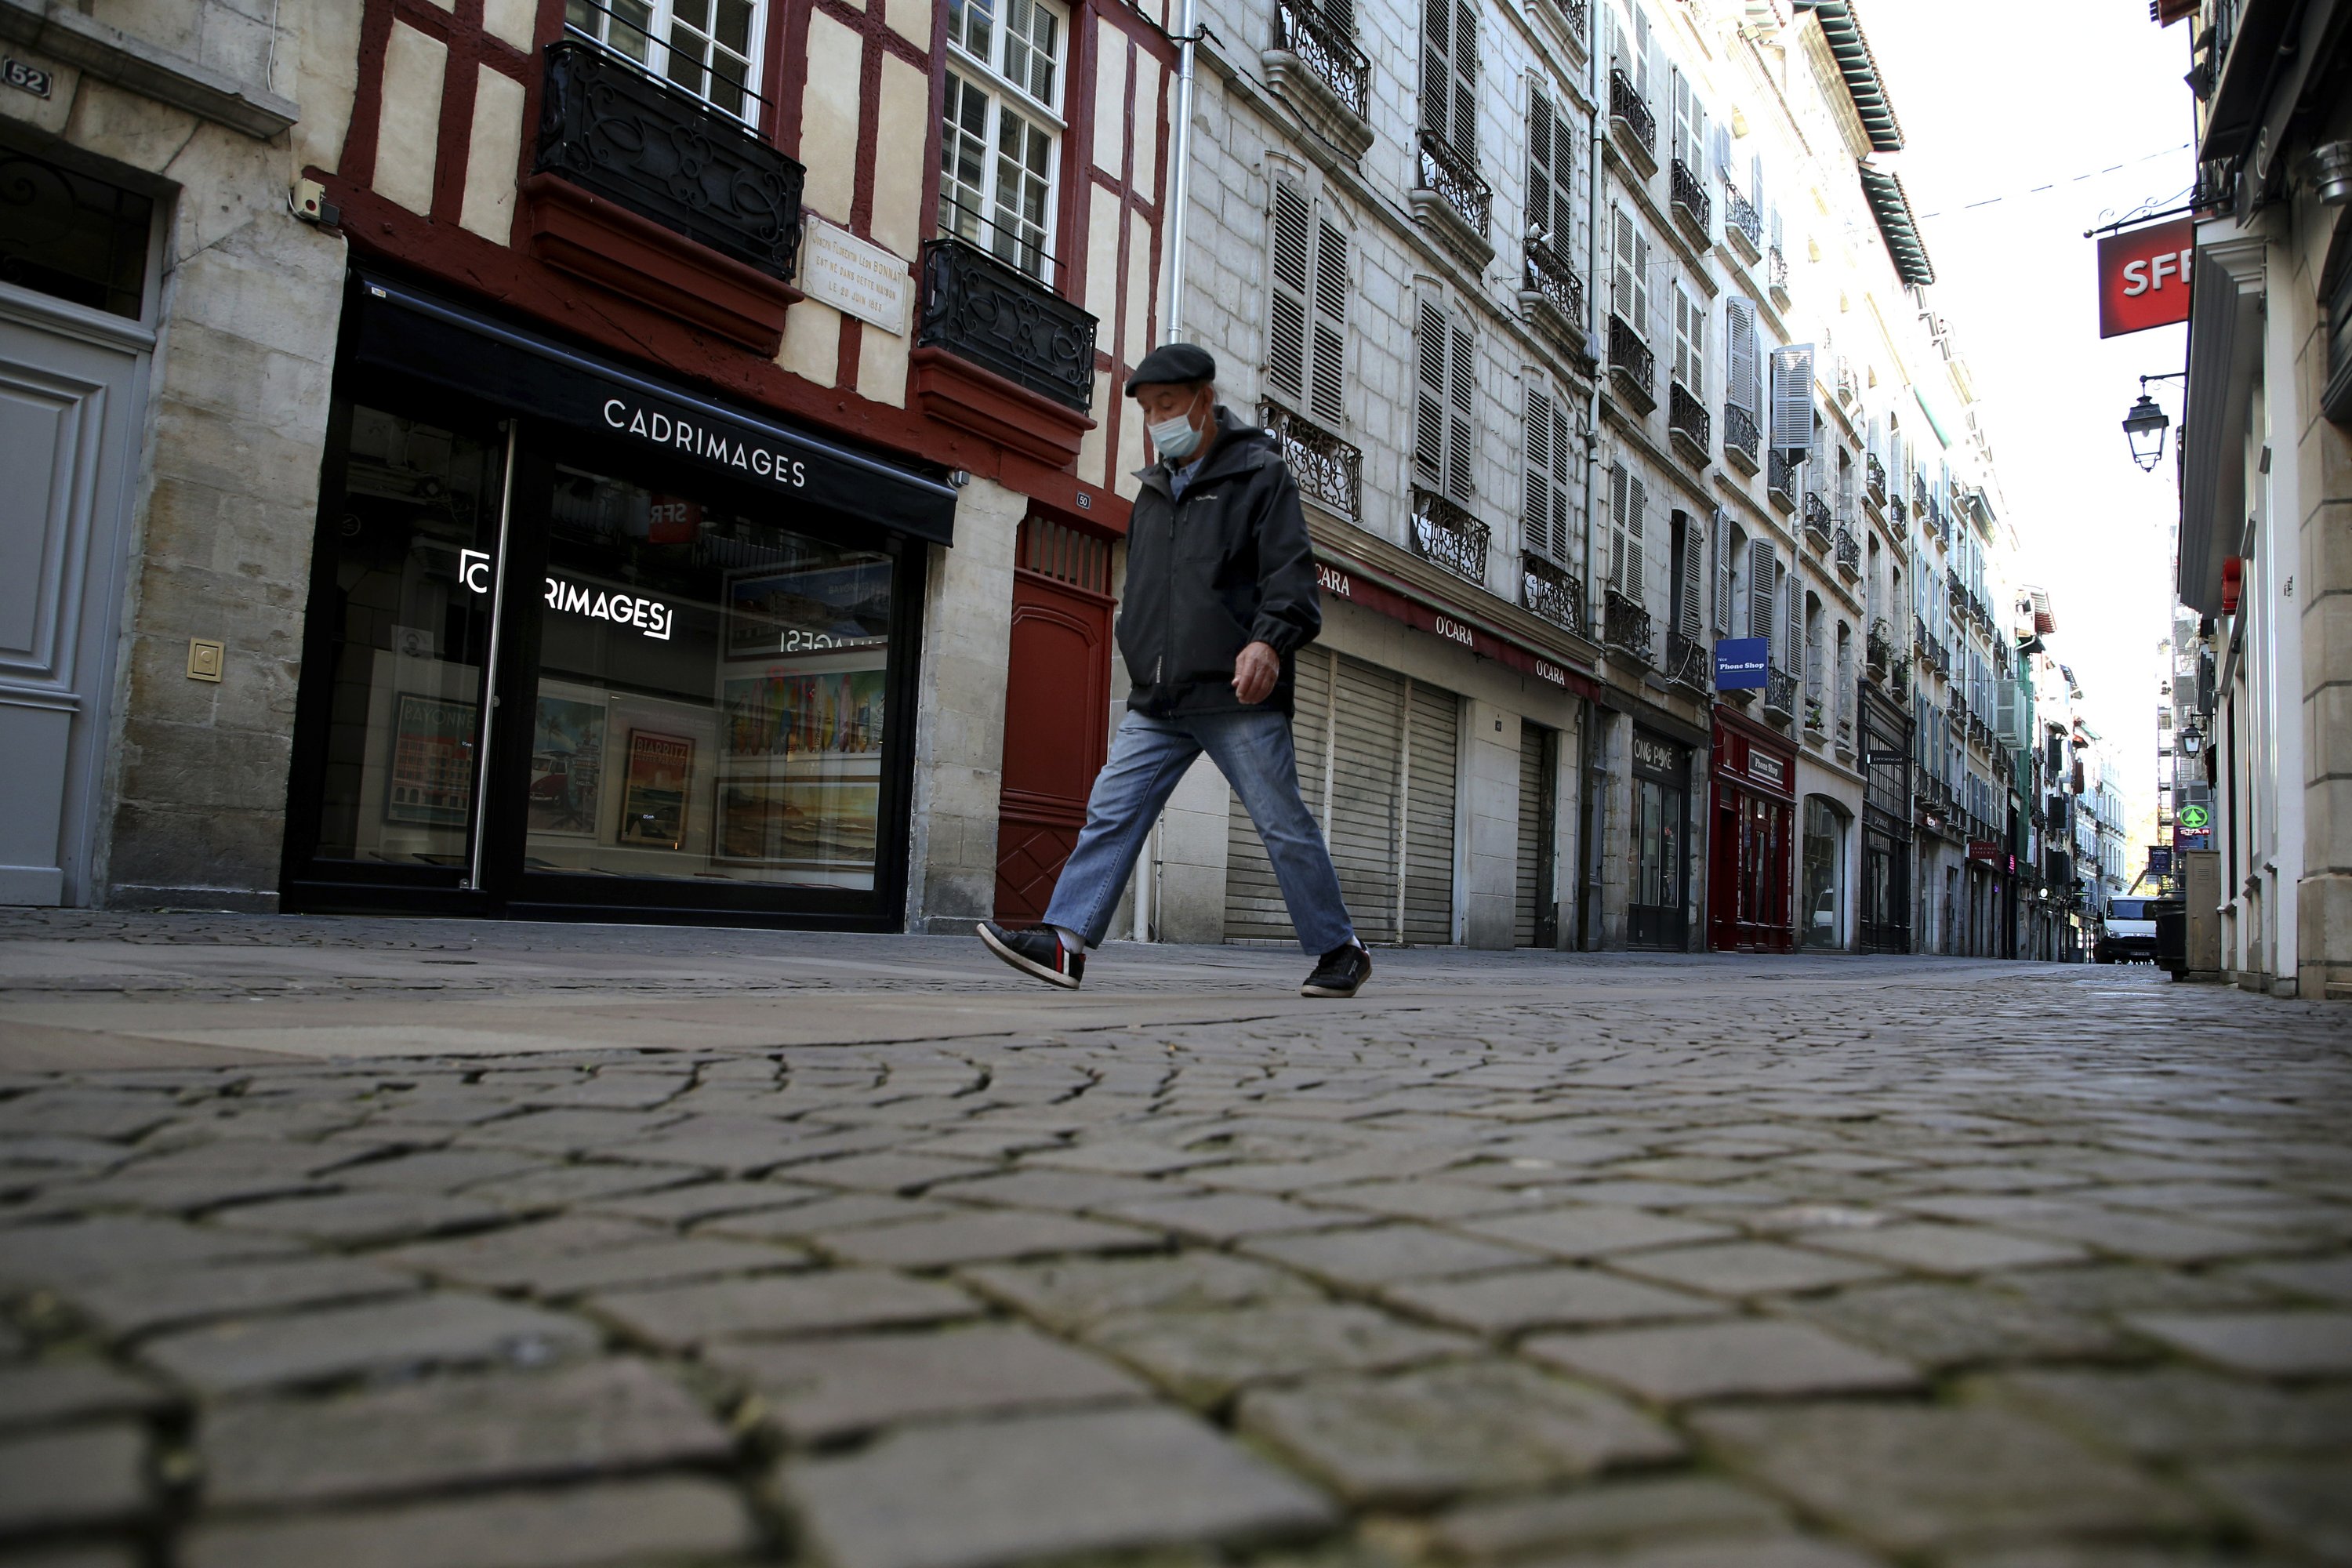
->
xmin=936 ymin=0 xmax=1070 ymax=287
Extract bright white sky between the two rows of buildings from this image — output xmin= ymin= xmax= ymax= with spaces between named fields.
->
xmin=1856 ymin=0 xmax=2194 ymax=862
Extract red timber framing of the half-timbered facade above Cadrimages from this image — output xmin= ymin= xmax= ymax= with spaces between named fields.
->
xmin=318 ymin=0 xmax=1176 ymax=534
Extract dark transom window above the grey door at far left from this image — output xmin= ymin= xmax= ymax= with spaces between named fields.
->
xmin=0 ymin=148 xmax=155 ymax=322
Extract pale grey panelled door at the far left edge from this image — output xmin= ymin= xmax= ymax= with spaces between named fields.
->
xmin=0 ymin=285 xmax=153 ymax=905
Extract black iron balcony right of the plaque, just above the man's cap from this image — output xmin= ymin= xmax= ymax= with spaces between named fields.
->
xmin=915 ymin=238 xmax=1094 ymax=412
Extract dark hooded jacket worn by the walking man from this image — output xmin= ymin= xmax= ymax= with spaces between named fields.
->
xmin=1120 ymin=405 xmax=1322 ymax=717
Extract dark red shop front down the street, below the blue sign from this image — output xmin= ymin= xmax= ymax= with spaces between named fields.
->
xmin=1708 ymin=708 xmax=1797 ymax=952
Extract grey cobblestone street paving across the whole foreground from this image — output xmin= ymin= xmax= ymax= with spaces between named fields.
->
xmin=0 ymin=912 xmax=2352 ymax=1568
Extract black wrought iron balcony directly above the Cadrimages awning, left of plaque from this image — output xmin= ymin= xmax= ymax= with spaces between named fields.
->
xmin=532 ymin=38 xmax=814 ymax=281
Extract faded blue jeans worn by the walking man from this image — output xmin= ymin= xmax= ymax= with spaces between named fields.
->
xmin=1044 ymin=708 xmax=1355 ymax=956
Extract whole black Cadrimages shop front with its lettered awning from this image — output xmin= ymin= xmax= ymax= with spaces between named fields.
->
xmin=285 ymin=280 xmax=955 ymax=928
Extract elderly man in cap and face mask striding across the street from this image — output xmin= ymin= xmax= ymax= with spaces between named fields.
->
xmin=981 ymin=343 xmax=1371 ymax=996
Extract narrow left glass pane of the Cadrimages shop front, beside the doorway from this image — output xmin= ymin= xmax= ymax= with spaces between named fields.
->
xmin=318 ymin=409 xmax=503 ymax=867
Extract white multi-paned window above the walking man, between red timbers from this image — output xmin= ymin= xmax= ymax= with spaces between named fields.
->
xmin=938 ymin=0 xmax=1068 ymax=282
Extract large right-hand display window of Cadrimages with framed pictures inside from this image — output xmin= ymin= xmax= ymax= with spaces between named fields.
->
xmin=527 ymin=468 xmax=891 ymax=888
